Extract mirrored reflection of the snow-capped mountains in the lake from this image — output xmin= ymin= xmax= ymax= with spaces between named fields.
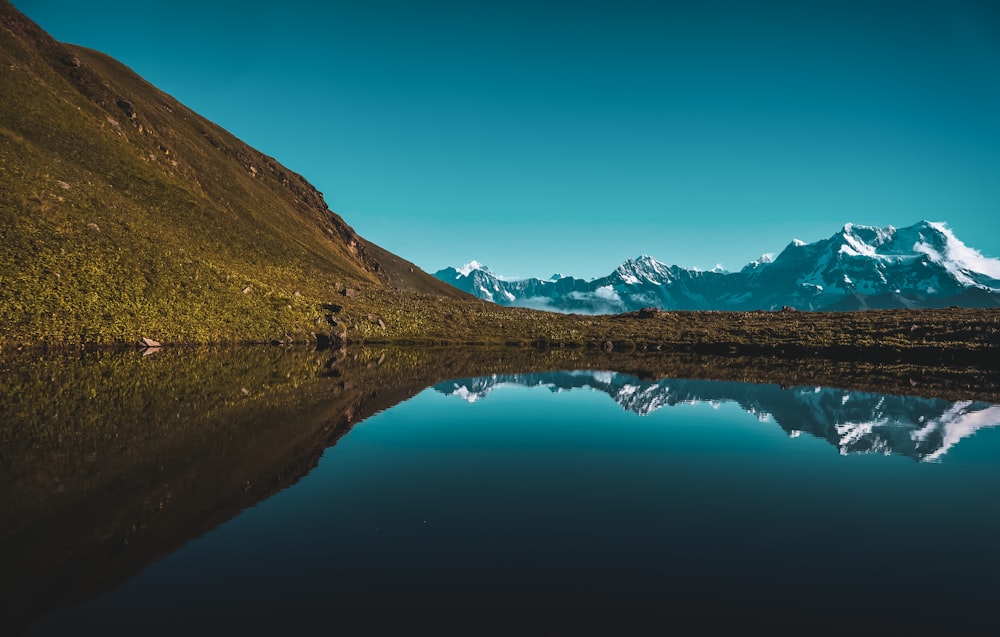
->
xmin=434 ymin=371 xmax=1000 ymax=462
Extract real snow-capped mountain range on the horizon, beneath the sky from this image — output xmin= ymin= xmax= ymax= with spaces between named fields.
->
xmin=435 ymin=221 xmax=1000 ymax=314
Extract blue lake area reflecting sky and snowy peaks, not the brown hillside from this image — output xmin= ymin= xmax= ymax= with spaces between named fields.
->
xmin=17 ymin=362 xmax=1000 ymax=635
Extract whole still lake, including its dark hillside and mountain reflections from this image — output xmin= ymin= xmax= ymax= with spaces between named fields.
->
xmin=0 ymin=348 xmax=1000 ymax=635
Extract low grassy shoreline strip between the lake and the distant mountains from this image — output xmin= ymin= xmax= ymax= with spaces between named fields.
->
xmin=0 ymin=285 xmax=1000 ymax=367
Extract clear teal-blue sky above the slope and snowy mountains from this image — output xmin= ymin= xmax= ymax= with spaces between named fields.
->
xmin=14 ymin=0 xmax=1000 ymax=278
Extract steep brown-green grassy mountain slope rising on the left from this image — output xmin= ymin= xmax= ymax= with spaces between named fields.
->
xmin=0 ymin=1 xmax=464 ymax=343
